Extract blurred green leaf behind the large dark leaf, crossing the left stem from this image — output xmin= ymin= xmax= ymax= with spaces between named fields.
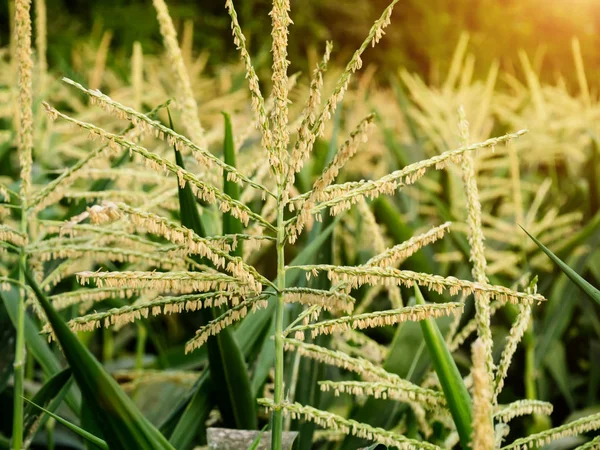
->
xmin=0 ymin=286 xmax=81 ymax=415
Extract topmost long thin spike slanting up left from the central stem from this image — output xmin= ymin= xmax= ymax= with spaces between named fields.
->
xmin=57 ymin=78 xmax=273 ymax=195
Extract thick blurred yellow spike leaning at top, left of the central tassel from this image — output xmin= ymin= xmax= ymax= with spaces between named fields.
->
xmin=152 ymin=0 xmax=206 ymax=147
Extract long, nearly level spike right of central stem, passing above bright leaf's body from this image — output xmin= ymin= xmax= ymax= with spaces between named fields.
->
xmin=287 ymin=264 xmax=546 ymax=304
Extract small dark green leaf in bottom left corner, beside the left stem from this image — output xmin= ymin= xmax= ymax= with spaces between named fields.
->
xmin=23 ymin=369 xmax=72 ymax=448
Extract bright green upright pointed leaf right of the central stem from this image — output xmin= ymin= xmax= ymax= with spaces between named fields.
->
xmin=415 ymin=284 xmax=473 ymax=450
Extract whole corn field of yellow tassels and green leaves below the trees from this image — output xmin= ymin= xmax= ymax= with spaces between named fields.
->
xmin=0 ymin=0 xmax=600 ymax=450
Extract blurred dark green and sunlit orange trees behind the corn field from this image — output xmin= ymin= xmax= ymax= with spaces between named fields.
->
xmin=0 ymin=0 xmax=600 ymax=86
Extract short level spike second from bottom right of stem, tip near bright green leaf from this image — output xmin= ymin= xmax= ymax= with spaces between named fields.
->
xmin=319 ymin=380 xmax=446 ymax=410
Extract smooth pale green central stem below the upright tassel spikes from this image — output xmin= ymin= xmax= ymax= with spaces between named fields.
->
xmin=271 ymin=201 xmax=285 ymax=450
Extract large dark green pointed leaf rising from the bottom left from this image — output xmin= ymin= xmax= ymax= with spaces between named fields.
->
xmin=22 ymin=267 xmax=173 ymax=450
